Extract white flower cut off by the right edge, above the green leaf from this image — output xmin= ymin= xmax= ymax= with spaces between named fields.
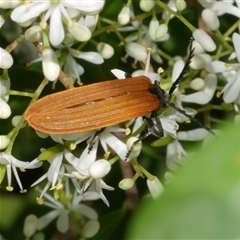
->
xmin=206 ymin=33 xmax=240 ymax=103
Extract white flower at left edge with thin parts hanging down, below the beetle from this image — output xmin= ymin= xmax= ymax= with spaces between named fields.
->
xmin=0 ymin=152 xmax=42 ymax=192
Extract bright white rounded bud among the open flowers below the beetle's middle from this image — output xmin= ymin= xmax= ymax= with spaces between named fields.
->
xmin=88 ymin=159 xmax=111 ymax=179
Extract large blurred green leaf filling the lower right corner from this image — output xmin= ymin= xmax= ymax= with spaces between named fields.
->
xmin=127 ymin=123 xmax=240 ymax=239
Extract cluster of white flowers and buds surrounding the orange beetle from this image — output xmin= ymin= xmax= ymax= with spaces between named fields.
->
xmin=0 ymin=0 xmax=240 ymax=238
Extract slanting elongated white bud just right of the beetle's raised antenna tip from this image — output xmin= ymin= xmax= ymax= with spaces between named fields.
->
xmin=193 ymin=29 xmax=216 ymax=52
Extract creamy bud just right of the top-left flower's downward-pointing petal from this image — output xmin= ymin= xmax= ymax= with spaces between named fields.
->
xmin=68 ymin=22 xmax=92 ymax=42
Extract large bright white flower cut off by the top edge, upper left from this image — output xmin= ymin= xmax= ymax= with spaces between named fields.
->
xmin=11 ymin=0 xmax=104 ymax=46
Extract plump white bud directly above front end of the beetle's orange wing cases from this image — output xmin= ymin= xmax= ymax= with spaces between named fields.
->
xmin=125 ymin=42 xmax=147 ymax=61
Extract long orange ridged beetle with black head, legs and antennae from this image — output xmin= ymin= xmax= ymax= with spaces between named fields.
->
xmin=25 ymin=41 xmax=212 ymax=157
